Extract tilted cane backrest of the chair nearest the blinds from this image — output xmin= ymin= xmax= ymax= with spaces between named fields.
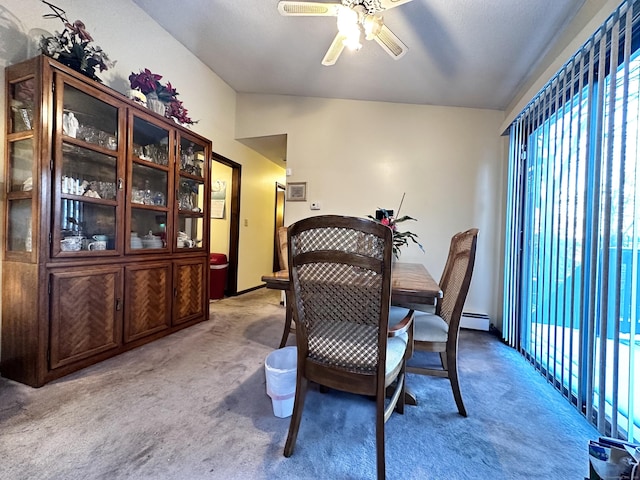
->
xmin=436 ymin=228 xmax=478 ymax=332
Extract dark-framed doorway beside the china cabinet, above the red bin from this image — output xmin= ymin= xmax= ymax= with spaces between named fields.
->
xmin=210 ymin=152 xmax=242 ymax=296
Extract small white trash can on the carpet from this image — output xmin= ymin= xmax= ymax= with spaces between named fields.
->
xmin=264 ymin=347 xmax=298 ymax=418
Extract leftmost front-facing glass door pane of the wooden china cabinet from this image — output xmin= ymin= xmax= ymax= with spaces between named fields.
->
xmin=52 ymin=78 xmax=123 ymax=256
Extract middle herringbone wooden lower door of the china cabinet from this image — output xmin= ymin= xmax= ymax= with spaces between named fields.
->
xmin=124 ymin=263 xmax=171 ymax=342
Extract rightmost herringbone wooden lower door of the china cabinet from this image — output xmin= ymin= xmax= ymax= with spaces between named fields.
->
xmin=173 ymin=258 xmax=208 ymax=325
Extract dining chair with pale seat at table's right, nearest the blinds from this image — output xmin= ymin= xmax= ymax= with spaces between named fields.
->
xmin=407 ymin=228 xmax=478 ymax=417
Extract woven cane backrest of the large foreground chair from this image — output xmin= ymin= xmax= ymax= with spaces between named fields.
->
xmin=288 ymin=215 xmax=393 ymax=384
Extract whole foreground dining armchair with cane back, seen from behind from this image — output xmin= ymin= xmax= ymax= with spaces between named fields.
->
xmin=284 ymin=215 xmax=413 ymax=479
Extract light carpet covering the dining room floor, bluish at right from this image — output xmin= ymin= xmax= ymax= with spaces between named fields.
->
xmin=0 ymin=289 xmax=597 ymax=480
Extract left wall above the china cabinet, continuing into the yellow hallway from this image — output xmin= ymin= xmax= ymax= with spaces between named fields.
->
xmin=0 ymin=0 xmax=285 ymax=314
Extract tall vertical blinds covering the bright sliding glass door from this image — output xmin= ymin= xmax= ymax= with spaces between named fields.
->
xmin=503 ymin=0 xmax=640 ymax=441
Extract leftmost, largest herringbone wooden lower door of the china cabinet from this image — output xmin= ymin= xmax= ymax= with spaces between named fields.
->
xmin=50 ymin=267 xmax=122 ymax=369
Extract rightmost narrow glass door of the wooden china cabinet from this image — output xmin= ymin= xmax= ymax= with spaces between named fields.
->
xmin=174 ymin=133 xmax=208 ymax=249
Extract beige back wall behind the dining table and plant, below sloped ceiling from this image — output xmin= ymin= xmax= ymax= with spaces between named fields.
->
xmin=236 ymin=95 xmax=506 ymax=322
